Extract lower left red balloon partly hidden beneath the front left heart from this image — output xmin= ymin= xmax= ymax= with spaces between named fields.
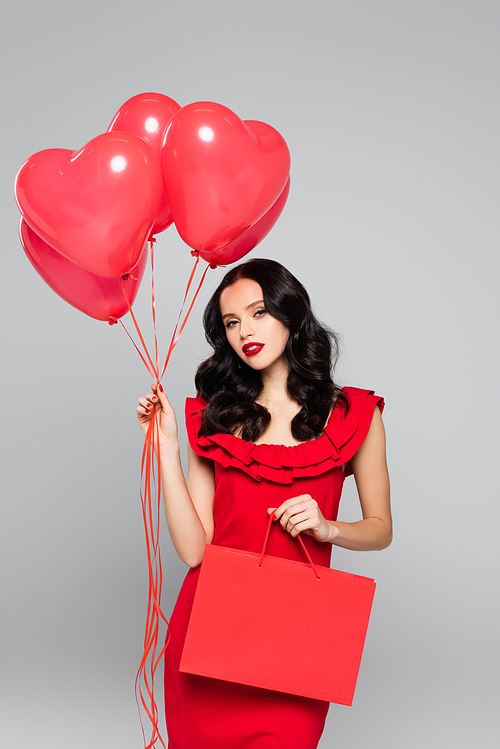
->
xmin=19 ymin=219 xmax=148 ymax=321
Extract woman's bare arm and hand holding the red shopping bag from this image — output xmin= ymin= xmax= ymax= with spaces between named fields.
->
xmin=269 ymin=408 xmax=392 ymax=551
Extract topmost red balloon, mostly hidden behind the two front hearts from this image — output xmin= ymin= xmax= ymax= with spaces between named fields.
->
xmin=107 ymin=92 xmax=181 ymax=234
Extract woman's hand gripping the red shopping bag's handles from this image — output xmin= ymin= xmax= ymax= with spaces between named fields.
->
xmin=268 ymin=494 xmax=340 ymax=543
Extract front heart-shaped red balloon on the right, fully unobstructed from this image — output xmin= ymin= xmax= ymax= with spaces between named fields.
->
xmin=161 ymin=102 xmax=290 ymax=252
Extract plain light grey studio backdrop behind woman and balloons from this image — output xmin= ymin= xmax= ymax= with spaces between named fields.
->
xmin=0 ymin=0 xmax=500 ymax=749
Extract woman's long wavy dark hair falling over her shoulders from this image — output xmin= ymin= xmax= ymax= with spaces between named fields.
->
xmin=195 ymin=259 xmax=349 ymax=442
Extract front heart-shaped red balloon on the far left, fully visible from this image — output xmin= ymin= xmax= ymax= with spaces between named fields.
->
xmin=15 ymin=132 xmax=162 ymax=278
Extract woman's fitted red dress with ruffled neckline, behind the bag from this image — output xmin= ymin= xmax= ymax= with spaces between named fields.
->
xmin=165 ymin=387 xmax=384 ymax=749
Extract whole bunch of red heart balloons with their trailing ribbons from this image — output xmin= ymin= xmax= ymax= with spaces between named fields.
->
xmin=15 ymin=93 xmax=290 ymax=749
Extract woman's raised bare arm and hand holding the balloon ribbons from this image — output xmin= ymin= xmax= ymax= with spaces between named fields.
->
xmin=137 ymin=385 xmax=215 ymax=567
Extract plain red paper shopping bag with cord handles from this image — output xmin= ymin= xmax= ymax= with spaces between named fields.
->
xmin=180 ymin=526 xmax=375 ymax=705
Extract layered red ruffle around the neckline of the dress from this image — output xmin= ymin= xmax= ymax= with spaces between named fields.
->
xmin=186 ymin=387 xmax=384 ymax=484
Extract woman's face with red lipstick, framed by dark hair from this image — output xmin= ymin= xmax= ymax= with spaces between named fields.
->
xmin=220 ymin=278 xmax=288 ymax=371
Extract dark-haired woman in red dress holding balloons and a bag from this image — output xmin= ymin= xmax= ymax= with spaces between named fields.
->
xmin=137 ymin=260 xmax=392 ymax=749
